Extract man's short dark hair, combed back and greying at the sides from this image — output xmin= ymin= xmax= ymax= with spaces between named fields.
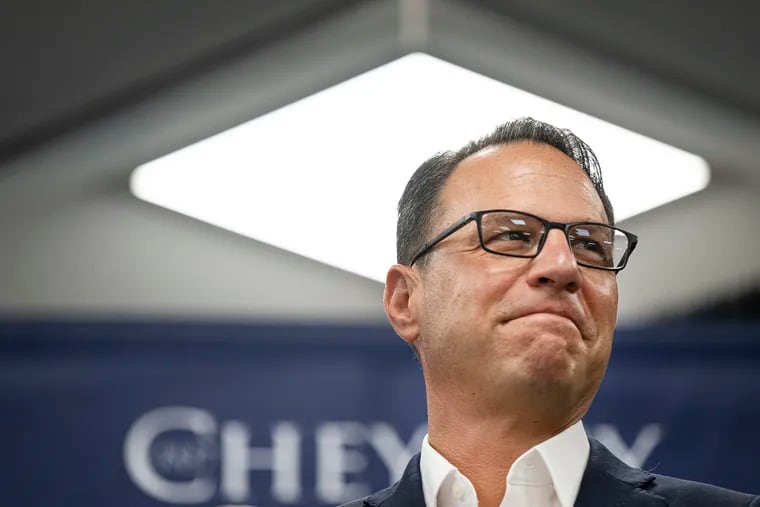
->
xmin=396 ymin=118 xmax=615 ymax=266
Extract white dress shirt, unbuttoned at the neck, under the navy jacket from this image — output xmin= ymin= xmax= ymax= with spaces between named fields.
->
xmin=420 ymin=421 xmax=589 ymax=507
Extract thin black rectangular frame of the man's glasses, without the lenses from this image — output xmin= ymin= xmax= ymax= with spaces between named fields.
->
xmin=409 ymin=209 xmax=639 ymax=273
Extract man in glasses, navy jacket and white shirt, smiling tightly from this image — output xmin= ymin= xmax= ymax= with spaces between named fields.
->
xmin=346 ymin=118 xmax=760 ymax=507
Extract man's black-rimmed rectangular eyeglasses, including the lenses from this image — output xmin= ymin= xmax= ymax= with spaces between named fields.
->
xmin=409 ymin=209 xmax=638 ymax=272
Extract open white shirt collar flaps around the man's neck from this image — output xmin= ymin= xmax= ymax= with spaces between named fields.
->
xmin=420 ymin=421 xmax=589 ymax=507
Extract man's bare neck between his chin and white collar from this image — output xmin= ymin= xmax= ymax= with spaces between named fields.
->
xmin=427 ymin=384 xmax=580 ymax=507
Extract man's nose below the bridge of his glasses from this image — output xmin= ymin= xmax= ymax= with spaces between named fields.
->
xmin=528 ymin=229 xmax=583 ymax=292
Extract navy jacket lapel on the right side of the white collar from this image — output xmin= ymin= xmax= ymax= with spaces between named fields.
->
xmin=575 ymin=438 xmax=668 ymax=507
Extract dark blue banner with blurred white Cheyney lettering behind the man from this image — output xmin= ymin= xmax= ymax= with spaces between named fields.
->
xmin=0 ymin=323 xmax=760 ymax=507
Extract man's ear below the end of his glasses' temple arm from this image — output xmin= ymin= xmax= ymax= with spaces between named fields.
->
xmin=383 ymin=264 xmax=420 ymax=345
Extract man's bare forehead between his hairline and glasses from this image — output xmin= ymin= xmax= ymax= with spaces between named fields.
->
xmin=439 ymin=142 xmax=606 ymax=223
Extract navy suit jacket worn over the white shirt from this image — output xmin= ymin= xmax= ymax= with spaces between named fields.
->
xmin=342 ymin=438 xmax=760 ymax=507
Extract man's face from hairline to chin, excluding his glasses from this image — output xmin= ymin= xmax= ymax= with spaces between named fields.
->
xmin=410 ymin=142 xmax=618 ymax=417
